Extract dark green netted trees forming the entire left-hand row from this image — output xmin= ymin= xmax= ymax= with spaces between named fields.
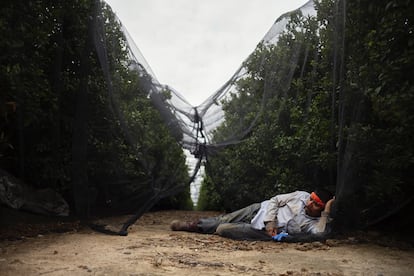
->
xmin=0 ymin=0 xmax=191 ymax=215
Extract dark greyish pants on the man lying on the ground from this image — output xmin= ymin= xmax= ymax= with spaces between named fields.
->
xmin=197 ymin=203 xmax=272 ymax=240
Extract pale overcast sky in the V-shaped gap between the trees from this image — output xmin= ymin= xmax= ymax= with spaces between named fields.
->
xmin=106 ymin=0 xmax=307 ymax=106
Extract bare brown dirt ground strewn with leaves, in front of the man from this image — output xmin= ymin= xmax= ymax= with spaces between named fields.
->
xmin=0 ymin=208 xmax=414 ymax=276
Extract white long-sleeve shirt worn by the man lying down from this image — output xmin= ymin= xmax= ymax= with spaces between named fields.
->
xmin=251 ymin=191 xmax=328 ymax=234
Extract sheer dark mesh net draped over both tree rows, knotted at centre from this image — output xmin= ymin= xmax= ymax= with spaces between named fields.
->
xmin=1 ymin=0 xmax=414 ymax=234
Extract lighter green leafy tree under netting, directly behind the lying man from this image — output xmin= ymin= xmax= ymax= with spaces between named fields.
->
xmin=199 ymin=4 xmax=335 ymax=211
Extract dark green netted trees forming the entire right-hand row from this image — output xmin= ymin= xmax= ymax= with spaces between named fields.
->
xmin=199 ymin=0 xmax=414 ymax=220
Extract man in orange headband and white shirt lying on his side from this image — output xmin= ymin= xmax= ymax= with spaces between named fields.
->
xmin=171 ymin=190 xmax=335 ymax=241
